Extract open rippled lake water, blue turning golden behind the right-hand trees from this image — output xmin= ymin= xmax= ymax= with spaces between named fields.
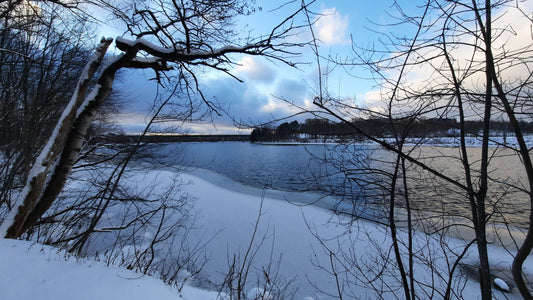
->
xmin=153 ymin=142 xmax=529 ymax=227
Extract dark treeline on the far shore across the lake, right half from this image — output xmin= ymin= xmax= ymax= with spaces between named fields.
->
xmin=250 ymin=118 xmax=533 ymax=142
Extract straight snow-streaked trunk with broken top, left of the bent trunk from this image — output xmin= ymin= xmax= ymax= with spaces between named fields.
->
xmin=0 ymin=39 xmax=112 ymax=238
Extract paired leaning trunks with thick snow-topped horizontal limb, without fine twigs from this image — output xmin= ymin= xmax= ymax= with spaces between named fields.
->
xmin=0 ymin=28 xmax=272 ymax=238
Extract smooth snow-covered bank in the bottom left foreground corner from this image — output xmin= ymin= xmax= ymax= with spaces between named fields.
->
xmin=0 ymin=239 xmax=217 ymax=300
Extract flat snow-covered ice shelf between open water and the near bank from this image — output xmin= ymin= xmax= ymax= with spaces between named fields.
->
xmin=59 ymin=164 xmax=533 ymax=299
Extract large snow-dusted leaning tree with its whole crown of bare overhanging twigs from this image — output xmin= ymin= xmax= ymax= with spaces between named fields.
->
xmin=1 ymin=1 xmax=310 ymax=268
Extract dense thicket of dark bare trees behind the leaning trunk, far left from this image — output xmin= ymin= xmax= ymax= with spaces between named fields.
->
xmin=0 ymin=1 xmax=92 ymax=218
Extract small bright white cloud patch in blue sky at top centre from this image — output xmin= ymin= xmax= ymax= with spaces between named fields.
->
xmin=315 ymin=7 xmax=349 ymax=45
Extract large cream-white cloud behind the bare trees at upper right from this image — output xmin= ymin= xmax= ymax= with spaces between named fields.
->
xmin=359 ymin=1 xmax=533 ymax=115
